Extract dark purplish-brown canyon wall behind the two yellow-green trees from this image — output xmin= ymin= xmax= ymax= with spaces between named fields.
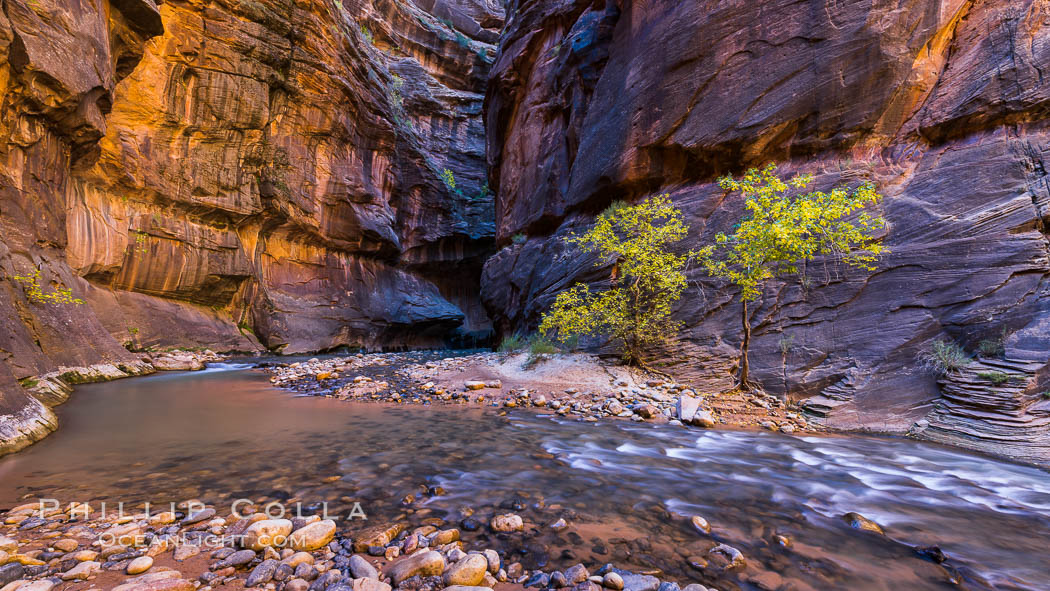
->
xmin=482 ymin=0 xmax=1050 ymax=460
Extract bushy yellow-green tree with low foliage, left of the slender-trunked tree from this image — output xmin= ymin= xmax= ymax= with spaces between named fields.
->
xmin=540 ymin=195 xmax=690 ymax=365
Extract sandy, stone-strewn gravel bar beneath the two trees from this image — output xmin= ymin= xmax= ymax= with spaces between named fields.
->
xmin=266 ymin=352 xmax=819 ymax=434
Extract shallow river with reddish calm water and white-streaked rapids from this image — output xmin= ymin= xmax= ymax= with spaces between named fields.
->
xmin=0 ymin=364 xmax=1050 ymax=591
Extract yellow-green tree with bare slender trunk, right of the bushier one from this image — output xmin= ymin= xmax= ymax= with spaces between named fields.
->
xmin=697 ymin=164 xmax=888 ymax=389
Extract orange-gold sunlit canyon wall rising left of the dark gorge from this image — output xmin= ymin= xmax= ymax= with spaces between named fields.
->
xmin=0 ymin=0 xmax=503 ymax=452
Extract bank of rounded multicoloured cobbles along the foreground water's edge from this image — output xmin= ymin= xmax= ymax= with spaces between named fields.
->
xmin=0 ymin=500 xmax=739 ymax=591
